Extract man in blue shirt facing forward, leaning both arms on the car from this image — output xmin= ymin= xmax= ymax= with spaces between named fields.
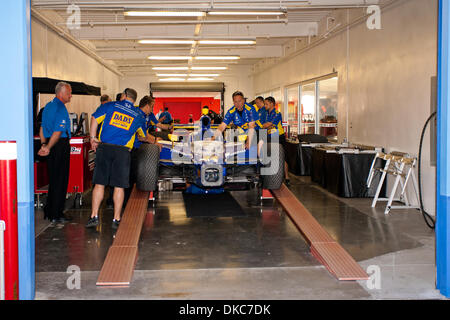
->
xmin=214 ymin=91 xmax=260 ymax=149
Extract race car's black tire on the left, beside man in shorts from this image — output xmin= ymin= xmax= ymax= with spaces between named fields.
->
xmin=136 ymin=143 xmax=159 ymax=191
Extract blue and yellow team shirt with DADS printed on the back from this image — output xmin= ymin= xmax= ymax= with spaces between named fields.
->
xmin=92 ymin=100 xmax=147 ymax=149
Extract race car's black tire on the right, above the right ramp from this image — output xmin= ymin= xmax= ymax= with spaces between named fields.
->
xmin=261 ymin=143 xmax=284 ymax=190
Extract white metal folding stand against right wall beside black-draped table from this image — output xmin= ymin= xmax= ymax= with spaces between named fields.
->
xmin=367 ymin=152 xmax=419 ymax=215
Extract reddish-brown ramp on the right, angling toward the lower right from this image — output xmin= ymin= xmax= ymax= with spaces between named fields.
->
xmin=272 ymin=184 xmax=369 ymax=281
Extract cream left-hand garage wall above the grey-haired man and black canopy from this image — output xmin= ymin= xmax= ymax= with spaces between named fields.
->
xmin=31 ymin=18 xmax=120 ymax=99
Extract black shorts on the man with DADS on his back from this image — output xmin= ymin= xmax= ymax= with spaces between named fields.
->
xmin=92 ymin=143 xmax=131 ymax=188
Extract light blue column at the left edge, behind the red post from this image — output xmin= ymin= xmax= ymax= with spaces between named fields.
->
xmin=0 ymin=0 xmax=35 ymax=300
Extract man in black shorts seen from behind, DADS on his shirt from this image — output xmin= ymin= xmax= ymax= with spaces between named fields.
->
xmin=86 ymin=88 xmax=146 ymax=228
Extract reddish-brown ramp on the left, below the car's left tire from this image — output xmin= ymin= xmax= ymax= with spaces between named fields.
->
xmin=97 ymin=186 xmax=149 ymax=287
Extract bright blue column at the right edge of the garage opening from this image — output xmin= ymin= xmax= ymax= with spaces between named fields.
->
xmin=436 ymin=0 xmax=450 ymax=298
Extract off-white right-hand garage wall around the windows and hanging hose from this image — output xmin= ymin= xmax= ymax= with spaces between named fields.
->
xmin=254 ymin=0 xmax=437 ymax=214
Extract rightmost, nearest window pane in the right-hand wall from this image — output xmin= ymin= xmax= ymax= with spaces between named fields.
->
xmin=318 ymin=77 xmax=338 ymax=141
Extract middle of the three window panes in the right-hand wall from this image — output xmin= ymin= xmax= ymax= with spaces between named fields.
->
xmin=300 ymin=82 xmax=316 ymax=134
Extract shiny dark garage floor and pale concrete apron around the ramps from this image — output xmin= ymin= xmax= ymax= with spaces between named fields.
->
xmin=36 ymin=177 xmax=443 ymax=299
